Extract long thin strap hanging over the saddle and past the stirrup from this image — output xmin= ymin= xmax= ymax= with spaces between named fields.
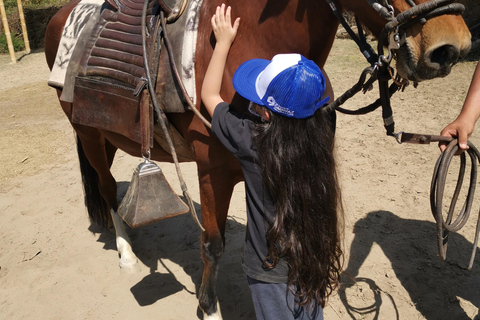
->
xmin=142 ymin=0 xmax=205 ymax=231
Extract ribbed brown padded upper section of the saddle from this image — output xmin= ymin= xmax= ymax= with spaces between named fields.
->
xmin=76 ymin=0 xmax=161 ymax=91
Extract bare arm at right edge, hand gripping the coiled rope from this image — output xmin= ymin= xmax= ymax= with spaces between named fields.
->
xmin=440 ymin=63 xmax=480 ymax=151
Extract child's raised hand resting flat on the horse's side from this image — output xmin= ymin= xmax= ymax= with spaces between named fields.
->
xmin=212 ymin=3 xmax=240 ymax=47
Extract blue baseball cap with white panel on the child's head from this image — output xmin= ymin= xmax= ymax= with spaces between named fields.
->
xmin=233 ymin=53 xmax=329 ymax=119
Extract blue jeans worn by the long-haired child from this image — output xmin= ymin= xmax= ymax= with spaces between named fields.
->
xmin=247 ymin=276 xmax=323 ymax=320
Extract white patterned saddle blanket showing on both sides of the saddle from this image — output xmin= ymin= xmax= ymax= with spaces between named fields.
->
xmin=48 ymin=0 xmax=203 ymax=103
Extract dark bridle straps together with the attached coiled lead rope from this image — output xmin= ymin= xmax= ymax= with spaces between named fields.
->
xmin=323 ymin=0 xmax=480 ymax=270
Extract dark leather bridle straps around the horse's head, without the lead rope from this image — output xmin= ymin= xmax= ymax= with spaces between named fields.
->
xmin=324 ymin=0 xmax=465 ymax=141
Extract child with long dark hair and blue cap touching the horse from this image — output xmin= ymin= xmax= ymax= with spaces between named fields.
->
xmin=201 ymin=5 xmax=342 ymax=320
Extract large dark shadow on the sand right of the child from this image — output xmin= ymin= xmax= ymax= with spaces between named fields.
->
xmin=339 ymin=211 xmax=480 ymax=320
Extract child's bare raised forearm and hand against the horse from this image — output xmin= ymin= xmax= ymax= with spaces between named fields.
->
xmin=201 ymin=4 xmax=240 ymax=116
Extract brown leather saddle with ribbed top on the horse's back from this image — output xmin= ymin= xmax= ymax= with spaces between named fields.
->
xmin=72 ymin=0 xmax=193 ymax=160
